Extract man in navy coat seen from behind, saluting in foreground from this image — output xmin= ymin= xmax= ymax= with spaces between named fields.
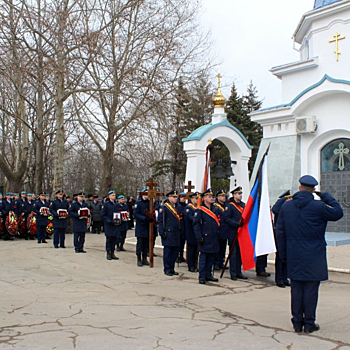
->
xmin=276 ymin=175 xmax=343 ymax=333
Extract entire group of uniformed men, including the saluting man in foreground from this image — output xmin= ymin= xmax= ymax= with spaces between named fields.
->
xmin=0 ymin=175 xmax=343 ymax=333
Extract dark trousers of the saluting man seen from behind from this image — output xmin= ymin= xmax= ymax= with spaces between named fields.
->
xmin=291 ymin=280 xmax=320 ymax=330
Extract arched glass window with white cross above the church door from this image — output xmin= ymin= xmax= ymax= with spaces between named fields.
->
xmin=321 ymin=139 xmax=350 ymax=173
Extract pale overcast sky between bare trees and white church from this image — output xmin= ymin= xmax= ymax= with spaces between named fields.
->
xmin=202 ymin=0 xmax=314 ymax=107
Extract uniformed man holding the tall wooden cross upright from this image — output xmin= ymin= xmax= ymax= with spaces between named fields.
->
xmin=134 ymin=188 xmax=153 ymax=267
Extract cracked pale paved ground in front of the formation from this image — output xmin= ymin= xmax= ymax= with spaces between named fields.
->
xmin=0 ymin=234 xmax=350 ymax=350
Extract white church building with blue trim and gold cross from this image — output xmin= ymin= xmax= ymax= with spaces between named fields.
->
xmin=251 ymin=0 xmax=350 ymax=232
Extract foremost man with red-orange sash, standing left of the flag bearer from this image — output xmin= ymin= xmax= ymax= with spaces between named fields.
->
xmin=194 ymin=188 xmax=220 ymax=284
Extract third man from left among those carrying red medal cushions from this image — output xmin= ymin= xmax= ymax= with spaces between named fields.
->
xmin=69 ymin=191 xmax=90 ymax=253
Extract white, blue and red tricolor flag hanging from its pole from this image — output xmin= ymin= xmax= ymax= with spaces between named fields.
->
xmin=238 ymin=151 xmax=276 ymax=271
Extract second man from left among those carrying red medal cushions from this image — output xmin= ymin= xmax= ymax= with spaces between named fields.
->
xmin=50 ymin=190 xmax=69 ymax=249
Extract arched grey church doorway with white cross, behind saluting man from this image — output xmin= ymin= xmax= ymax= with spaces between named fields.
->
xmin=320 ymin=138 xmax=350 ymax=232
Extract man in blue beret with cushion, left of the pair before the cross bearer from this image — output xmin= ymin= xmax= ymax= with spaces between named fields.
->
xmin=101 ymin=191 xmax=121 ymax=260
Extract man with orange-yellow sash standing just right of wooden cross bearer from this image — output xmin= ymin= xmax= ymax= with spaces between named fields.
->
xmin=158 ymin=190 xmax=183 ymax=276
